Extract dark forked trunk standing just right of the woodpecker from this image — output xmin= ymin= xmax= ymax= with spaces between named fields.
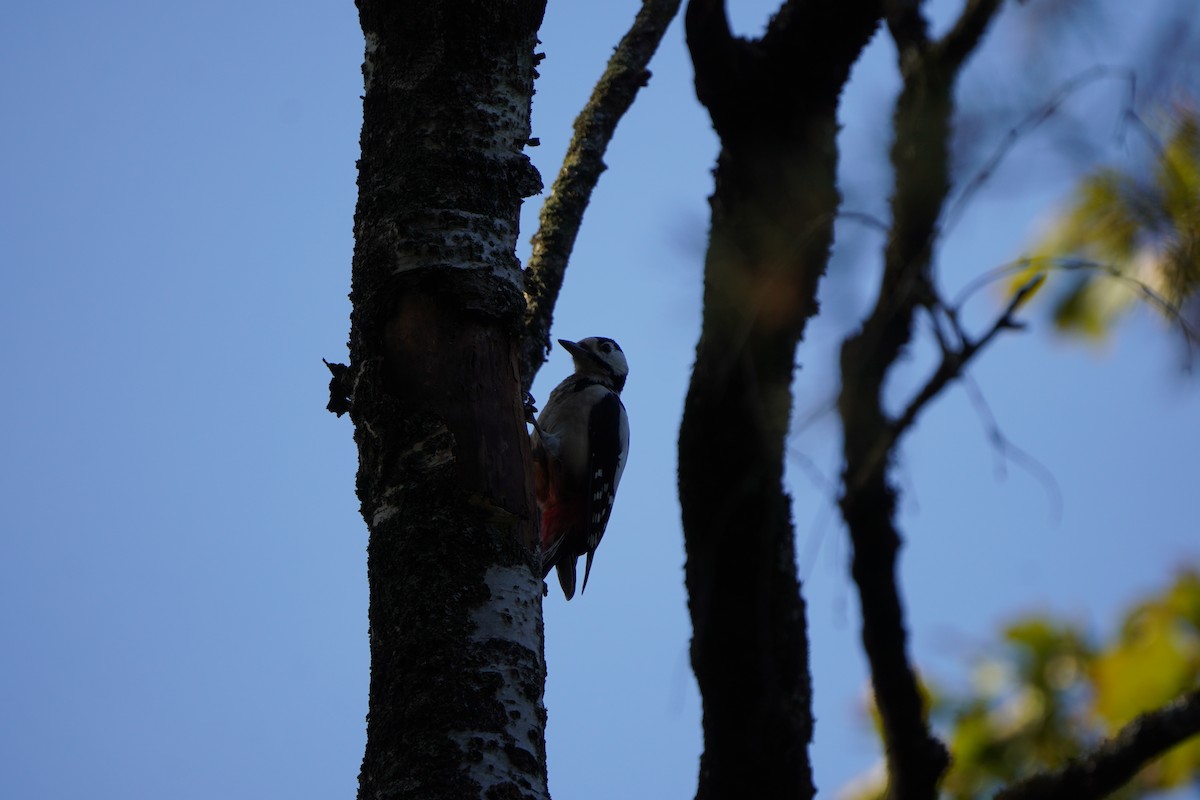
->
xmin=679 ymin=0 xmax=881 ymax=800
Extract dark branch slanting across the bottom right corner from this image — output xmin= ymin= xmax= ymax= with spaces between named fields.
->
xmin=996 ymin=690 xmax=1200 ymax=800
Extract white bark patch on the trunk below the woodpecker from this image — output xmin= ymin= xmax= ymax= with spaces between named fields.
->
xmin=451 ymin=566 xmax=550 ymax=800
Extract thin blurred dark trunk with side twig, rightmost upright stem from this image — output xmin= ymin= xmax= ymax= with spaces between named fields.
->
xmin=838 ymin=0 xmax=1008 ymax=800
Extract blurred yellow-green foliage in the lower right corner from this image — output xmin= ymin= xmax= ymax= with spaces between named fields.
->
xmin=839 ymin=570 xmax=1200 ymax=800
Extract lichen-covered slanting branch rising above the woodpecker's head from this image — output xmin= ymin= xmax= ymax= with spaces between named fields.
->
xmin=521 ymin=0 xmax=680 ymax=391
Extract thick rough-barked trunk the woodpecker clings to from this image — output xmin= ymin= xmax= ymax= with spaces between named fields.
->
xmin=350 ymin=0 xmax=546 ymax=799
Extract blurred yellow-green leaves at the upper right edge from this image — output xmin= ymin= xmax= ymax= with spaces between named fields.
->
xmin=1009 ymin=107 xmax=1200 ymax=338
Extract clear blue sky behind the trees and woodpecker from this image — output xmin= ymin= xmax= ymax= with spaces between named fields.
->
xmin=0 ymin=0 xmax=1200 ymax=800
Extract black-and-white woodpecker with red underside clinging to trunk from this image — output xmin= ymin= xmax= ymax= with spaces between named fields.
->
xmin=532 ymin=336 xmax=629 ymax=600
